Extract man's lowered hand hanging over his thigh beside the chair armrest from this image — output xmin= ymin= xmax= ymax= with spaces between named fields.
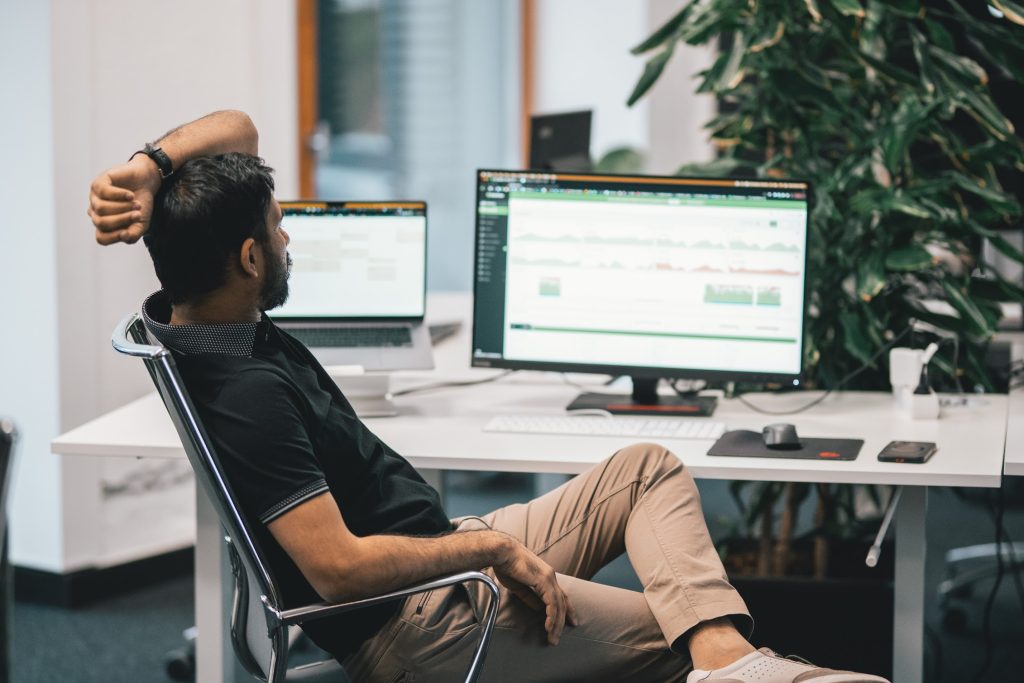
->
xmin=494 ymin=543 xmax=579 ymax=645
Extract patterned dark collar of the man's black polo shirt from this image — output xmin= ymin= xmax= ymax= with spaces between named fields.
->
xmin=142 ymin=290 xmax=270 ymax=357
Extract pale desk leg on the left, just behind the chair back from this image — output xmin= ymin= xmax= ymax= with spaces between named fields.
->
xmin=196 ymin=488 xmax=242 ymax=683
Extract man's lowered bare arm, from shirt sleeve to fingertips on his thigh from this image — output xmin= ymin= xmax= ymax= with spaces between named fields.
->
xmin=267 ymin=493 xmax=577 ymax=645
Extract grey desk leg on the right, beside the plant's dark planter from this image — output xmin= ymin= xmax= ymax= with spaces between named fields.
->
xmin=893 ymin=486 xmax=928 ymax=683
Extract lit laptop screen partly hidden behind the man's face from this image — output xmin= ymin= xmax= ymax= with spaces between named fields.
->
xmin=273 ymin=202 xmax=427 ymax=319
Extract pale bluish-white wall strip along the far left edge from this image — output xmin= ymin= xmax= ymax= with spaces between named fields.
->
xmin=0 ymin=1 xmax=63 ymax=569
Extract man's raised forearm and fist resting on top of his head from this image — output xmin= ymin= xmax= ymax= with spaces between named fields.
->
xmin=87 ymin=111 xmax=259 ymax=245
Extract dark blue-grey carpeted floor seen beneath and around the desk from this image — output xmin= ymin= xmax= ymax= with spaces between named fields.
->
xmin=11 ymin=473 xmax=1024 ymax=683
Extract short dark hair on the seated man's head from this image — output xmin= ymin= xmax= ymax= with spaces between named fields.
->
xmin=144 ymin=156 xmax=273 ymax=304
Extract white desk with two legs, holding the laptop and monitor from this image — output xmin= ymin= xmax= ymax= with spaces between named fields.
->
xmin=52 ymin=299 xmax=1008 ymax=683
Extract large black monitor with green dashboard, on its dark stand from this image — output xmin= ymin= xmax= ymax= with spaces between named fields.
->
xmin=471 ymin=170 xmax=810 ymax=415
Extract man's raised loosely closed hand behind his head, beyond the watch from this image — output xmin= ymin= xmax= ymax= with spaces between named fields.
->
xmin=88 ymin=155 xmax=160 ymax=245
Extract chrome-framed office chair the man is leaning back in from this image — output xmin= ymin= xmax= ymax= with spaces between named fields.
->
xmin=112 ymin=313 xmax=498 ymax=683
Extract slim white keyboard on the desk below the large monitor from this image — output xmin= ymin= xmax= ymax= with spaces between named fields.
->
xmin=483 ymin=415 xmax=727 ymax=439
